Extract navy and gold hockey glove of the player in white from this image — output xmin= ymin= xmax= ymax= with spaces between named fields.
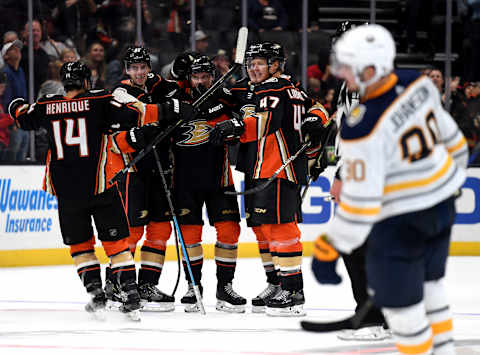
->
xmin=312 ymin=234 xmax=342 ymax=285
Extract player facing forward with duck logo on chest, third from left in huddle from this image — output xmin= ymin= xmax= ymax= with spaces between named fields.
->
xmin=173 ymin=56 xmax=246 ymax=313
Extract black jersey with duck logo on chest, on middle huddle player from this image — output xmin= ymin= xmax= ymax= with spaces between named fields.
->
xmin=172 ymin=87 xmax=233 ymax=190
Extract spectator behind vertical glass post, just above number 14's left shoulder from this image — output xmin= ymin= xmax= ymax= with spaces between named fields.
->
xmin=20 ymin=20 xmax=50 ymax=101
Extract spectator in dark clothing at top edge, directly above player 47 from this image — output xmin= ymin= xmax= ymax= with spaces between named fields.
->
xmin=248 ymin=0 xmax=288 ymax=32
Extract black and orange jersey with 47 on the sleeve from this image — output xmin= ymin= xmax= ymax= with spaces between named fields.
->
xmin=240 ymin=75 xmax=310 ymax=184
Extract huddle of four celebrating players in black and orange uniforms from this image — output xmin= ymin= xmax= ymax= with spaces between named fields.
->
xmin=10 ymin=42 xmax=330 ymax=315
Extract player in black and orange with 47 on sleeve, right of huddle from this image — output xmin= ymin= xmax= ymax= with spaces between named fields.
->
xmin=210 ymin=42 xmax=334 ymax=316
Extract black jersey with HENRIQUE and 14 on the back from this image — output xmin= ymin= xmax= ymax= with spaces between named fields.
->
xmin=16 ymin=90 xmax=148 ymax=199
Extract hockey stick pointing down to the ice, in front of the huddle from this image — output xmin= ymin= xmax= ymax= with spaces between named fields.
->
xmin=153 ymin=146 xmax=206 ymax=314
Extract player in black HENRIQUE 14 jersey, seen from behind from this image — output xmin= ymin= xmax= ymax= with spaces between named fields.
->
xmin=9 ymin=62 xmax=186 ymax=320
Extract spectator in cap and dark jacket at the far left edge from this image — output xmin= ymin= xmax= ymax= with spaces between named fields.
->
xmin=1 ymin=39 xmax=29 ymax=161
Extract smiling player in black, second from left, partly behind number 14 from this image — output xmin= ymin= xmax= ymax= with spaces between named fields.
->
xmin=106 ymin=46 xmax=189 ymax=312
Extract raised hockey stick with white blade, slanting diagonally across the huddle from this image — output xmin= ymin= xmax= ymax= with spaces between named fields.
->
xmin=109 ymin=27 xmax=248 ymax=184
